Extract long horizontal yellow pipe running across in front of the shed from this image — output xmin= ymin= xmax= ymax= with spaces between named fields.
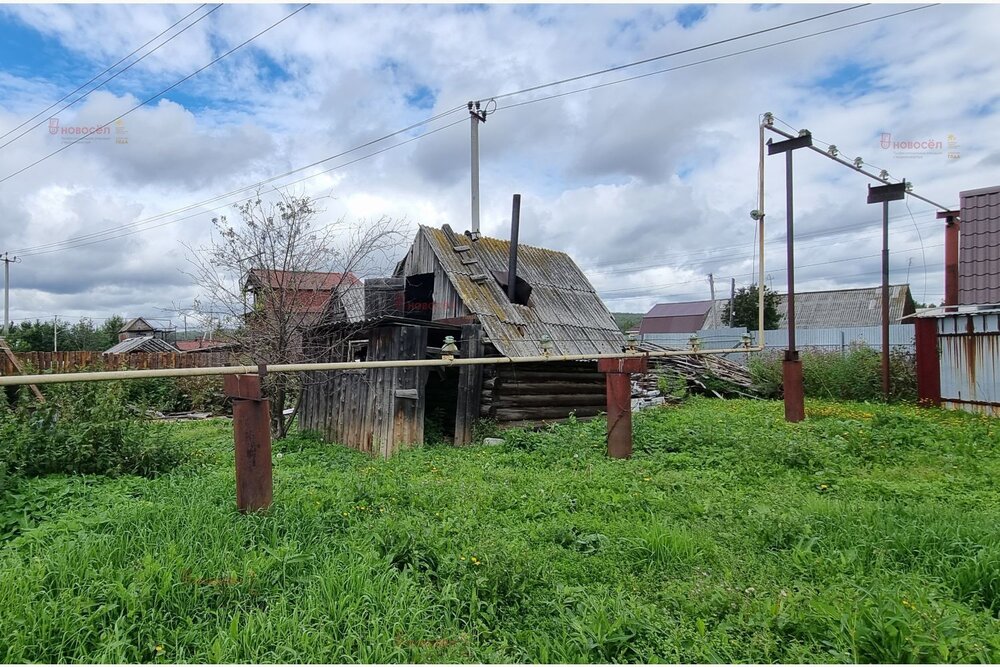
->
xmin=0 ymin=345 xmax=764 ymax=387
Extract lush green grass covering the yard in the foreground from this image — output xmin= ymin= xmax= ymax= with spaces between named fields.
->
xmin=0 ymin=399 xmax=1000 ymax=662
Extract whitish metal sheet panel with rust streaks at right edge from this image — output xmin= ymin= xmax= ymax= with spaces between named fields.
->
xmin=937 ymin=312 xmax=1000 ymax=416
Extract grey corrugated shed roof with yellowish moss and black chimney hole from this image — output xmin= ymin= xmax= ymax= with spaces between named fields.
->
xmin=418 ymin=225 xmax=625 ymax=357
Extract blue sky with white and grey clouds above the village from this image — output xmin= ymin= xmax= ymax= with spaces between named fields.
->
xmin=0 ymin=4 xmax=1000 ymax=332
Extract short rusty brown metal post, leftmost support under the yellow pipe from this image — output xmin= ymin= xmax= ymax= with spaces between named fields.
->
xmin=225 ymin=374 xmax=274 ymax=512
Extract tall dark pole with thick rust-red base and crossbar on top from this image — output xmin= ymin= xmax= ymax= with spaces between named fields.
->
xmin=767 ymin=130 xmax=812 ymax=422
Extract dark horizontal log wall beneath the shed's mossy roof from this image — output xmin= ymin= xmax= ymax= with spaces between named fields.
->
xmin=479 ymin=362 xmax=607 ymax=426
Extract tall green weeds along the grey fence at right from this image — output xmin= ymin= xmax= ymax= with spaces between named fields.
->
xmin=750 ymin=347 xmax=917 ymax=401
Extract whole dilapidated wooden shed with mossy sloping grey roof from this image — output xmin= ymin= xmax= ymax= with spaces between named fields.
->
xmin=300 ymin=225 xmax=625 ymax=456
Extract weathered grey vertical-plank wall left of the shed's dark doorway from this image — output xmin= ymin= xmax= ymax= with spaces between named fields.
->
xmin=300 ymin=326 xmax=427 ymax=457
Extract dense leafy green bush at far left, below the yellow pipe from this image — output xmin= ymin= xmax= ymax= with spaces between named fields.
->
xmin=0 ymin=382 xmax=181 ymax=476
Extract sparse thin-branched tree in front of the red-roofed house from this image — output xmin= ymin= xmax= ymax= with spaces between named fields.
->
xmin=185 ymin=190 xmax=406 ymax=438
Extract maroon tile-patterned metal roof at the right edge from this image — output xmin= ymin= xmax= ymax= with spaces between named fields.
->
xmin=958 ymin=186 xmax=1000 ymax=305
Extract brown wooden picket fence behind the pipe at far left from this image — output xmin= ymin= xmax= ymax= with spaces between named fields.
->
xmin=0 ymin=351 xmax=238 ymax=375
